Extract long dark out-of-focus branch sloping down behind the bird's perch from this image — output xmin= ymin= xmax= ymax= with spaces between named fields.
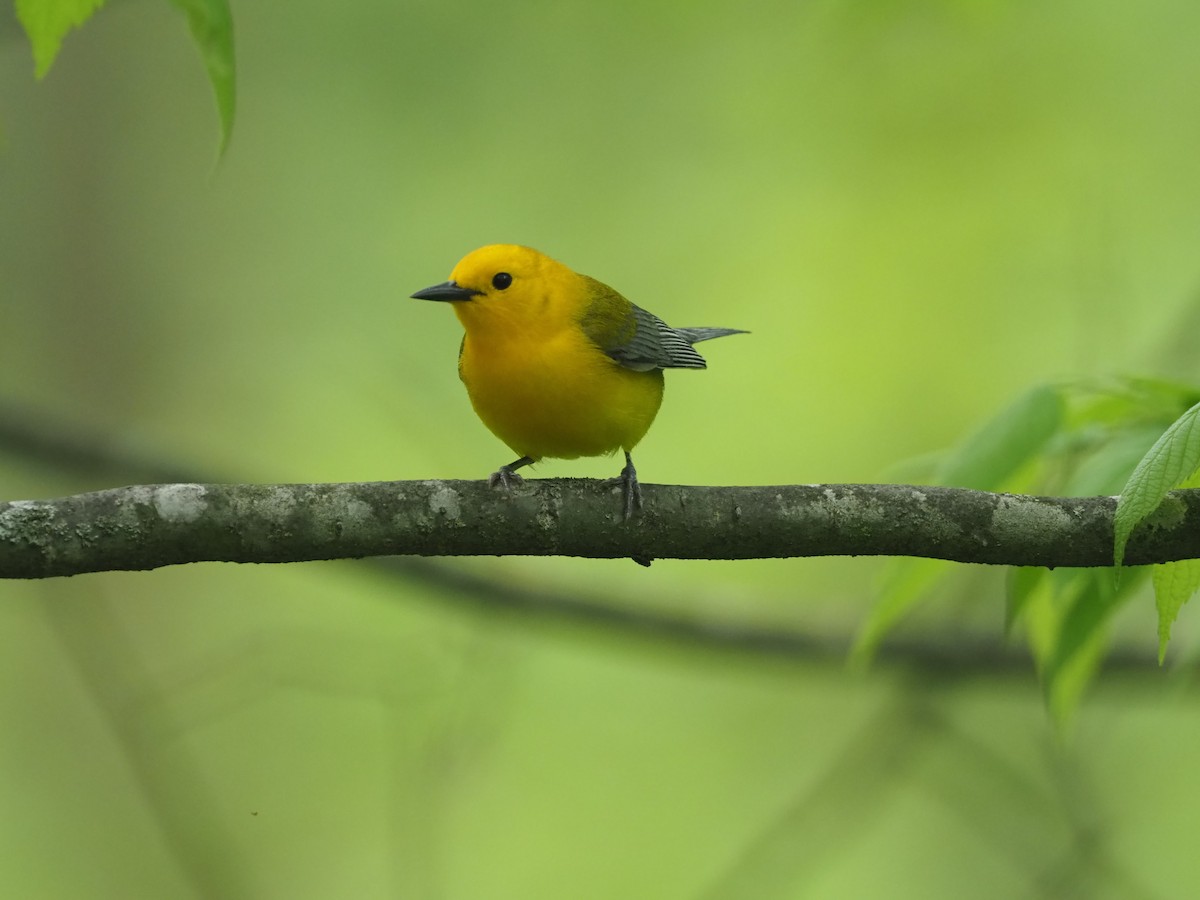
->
xmin=0 ymin=404 xmax=1160 ymax=677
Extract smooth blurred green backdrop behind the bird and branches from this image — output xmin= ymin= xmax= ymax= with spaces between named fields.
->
xmin=0 ymin=0 xmax=1200 ymax=900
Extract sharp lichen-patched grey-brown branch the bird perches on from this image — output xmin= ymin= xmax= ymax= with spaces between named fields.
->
xmin=0 ymin=479 xmax=1200 ymax=578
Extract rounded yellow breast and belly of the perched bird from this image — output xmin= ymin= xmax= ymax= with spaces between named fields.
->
xmin=460 ymin=334 xmax=662 ymax=460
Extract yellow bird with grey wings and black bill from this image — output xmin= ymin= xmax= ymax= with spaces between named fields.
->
xmin=412 ymin=244 xmax=746 ymax=522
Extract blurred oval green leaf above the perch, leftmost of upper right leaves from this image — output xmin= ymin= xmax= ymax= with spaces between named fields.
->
xmin=937 ymin=385 xmax=1063 ymax=491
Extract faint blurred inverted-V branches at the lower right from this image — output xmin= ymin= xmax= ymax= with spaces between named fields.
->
xmin=703 ymin=674 xmax=1156 ymax=900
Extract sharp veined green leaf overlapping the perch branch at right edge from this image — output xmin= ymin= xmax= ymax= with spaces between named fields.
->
xmin=1112 ymin=403 xmax=1200 ymax=570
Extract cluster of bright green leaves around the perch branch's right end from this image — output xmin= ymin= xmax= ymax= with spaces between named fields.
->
xmin=854 ymin=378 xmax=1200 ymax=722
